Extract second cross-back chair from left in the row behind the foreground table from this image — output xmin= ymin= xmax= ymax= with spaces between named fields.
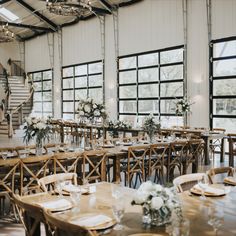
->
xmin=20 ymin=155 xmax=53 ymax=195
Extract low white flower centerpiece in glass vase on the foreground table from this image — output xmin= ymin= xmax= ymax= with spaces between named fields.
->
xmin=131 ymin=181 xmax=182 ymax=226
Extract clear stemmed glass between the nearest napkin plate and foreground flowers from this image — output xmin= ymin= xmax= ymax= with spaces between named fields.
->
xmin=112 ymin=198 xmax=125 ymax=230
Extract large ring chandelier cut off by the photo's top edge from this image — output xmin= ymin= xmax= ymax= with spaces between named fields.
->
xmin=46 ymin=0 xmax=92 ymax=16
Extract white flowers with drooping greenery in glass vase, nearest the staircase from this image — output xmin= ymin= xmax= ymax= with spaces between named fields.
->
xmin=23 ymin=117 xmax=52 ymax=155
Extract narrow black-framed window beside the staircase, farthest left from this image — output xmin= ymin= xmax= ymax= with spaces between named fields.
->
xmin=29 ymin=70 xmax=53 ymax=116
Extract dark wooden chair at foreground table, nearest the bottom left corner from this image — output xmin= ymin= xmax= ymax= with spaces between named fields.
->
xmin=11 ymin=194 xmax=52 ymax=236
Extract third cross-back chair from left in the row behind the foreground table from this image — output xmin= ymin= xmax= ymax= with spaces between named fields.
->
xmin=53 ymin=152 xmax=83 ymax=178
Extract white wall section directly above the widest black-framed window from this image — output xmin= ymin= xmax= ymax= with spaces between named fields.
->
xmin=119 ymin=0 xmax=183 ymax=55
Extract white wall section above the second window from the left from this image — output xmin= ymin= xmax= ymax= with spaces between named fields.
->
xmin=63 ymin=18 xmax=101 ymax=65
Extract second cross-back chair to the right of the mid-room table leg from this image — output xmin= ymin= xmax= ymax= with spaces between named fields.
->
xmin=148 ymin=143 xmax=169 ymax=184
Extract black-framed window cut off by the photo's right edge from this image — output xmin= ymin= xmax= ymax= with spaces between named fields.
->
xmin=210 ymin=37 xmax=236 ymax=132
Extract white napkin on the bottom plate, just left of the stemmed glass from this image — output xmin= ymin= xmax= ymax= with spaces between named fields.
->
xmin=72 ymin=214 xmax=112 ymax=227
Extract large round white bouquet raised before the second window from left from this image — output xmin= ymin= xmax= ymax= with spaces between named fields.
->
xmin=77 ymin=98 xmax=107 ymax=121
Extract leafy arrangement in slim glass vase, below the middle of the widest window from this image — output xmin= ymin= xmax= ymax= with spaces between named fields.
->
xmin=143 ymin=113 xmax=161 ymax=143
